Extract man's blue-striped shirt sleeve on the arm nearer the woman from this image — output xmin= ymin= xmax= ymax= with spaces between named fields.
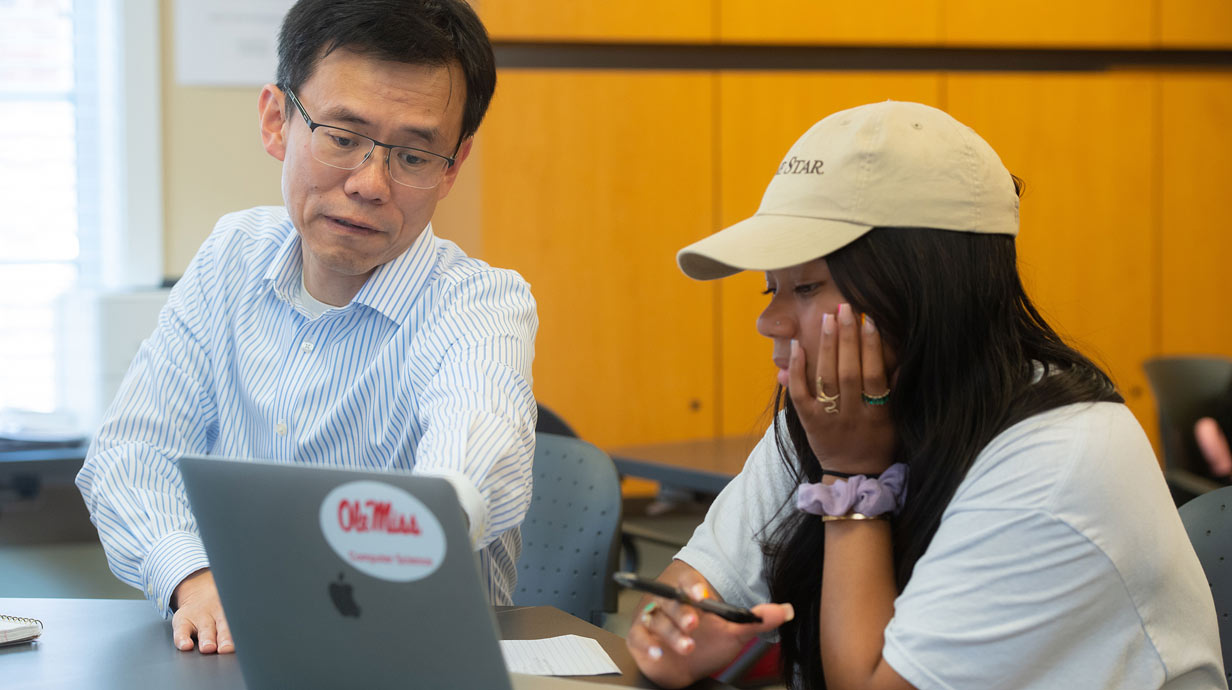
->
xmin=413 ymin=270 xmax=538 ymax=548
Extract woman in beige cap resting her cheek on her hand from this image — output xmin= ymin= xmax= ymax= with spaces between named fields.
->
xmin=628 ymin=102 xmax=1227 ymax=690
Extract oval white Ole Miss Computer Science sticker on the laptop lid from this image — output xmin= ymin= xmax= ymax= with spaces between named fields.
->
xmin=320 ymin=481 xmax=445 ymax=582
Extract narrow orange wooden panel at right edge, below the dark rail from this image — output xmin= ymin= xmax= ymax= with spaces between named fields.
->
xmin=1161 ymin=71 xmax=1232 ymax=355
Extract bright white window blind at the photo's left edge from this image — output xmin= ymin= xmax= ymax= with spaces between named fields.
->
xmin=0 ymin=0 xmax=101 ymax=410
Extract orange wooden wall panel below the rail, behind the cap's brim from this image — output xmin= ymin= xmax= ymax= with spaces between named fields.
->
xmin=714 ymin=71 xmax=941 ymax=435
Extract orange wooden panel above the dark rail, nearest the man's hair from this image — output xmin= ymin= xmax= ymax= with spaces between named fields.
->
xmin=478 ymin=0 xmax=715 ymax=43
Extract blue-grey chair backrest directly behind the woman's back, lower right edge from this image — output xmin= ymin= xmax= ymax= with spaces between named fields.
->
xmin=1180 ymin=487 xmax=1232 ymax=669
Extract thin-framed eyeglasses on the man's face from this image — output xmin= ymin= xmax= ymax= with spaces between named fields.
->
xmin=283 ymin=89 xmax=455 ymax=190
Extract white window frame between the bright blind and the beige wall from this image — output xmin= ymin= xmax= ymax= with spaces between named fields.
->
xmin=0 ymin=0 xmax=165 ymax=421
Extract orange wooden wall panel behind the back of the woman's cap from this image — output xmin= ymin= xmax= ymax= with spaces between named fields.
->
xmin=946 ymin=74 xmax=1159 ymax=437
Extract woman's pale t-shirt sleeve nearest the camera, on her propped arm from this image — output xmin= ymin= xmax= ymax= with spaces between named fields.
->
xmin=883 ymin=406 xmax=1164 ymax=690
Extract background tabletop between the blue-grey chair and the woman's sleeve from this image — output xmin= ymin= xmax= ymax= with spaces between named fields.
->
xmin=607 ymin=436 xmax=761 ymax=494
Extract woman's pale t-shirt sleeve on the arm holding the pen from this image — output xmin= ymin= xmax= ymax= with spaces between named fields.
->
xmin=676 ymin=425 xmax=796 ymax=607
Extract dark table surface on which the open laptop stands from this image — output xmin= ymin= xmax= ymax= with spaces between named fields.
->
xmin=0 ymin=599 xmax=728 ymax=690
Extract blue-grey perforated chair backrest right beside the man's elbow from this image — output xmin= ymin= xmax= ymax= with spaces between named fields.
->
xmin=514 ymin=434 xmax=621 ymax=625
